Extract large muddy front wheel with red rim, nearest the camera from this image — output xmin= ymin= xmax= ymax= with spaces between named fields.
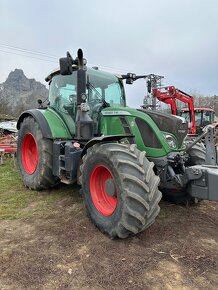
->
xmin=80 ymin=143 xmax=161 ymax=238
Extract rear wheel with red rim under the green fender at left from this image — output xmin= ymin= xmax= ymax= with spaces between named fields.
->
xmin=17 ymin=117 xmax=59 ymax=190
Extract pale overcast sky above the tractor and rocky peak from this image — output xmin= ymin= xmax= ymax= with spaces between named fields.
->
xmin=0 ymin=0 xmax=218 ymax=106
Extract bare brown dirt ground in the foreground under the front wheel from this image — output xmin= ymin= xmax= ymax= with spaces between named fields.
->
xmin=0 ymin=182 xmax=218 ymax=290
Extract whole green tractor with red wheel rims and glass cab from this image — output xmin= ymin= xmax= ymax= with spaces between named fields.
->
xmin=17 ymin=49 xmax=218 ymax=238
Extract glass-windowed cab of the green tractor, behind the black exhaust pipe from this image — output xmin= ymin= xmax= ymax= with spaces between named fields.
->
xmin=46 ymin=68 xmax=126 ymax=135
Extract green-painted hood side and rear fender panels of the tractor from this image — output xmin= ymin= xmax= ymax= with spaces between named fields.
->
xmin=34 ymin=102 xmax=186 ymax=157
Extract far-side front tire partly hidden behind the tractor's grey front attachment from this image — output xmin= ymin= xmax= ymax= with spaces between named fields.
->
xmin=162 ymin=143 xmax=206 ymax=206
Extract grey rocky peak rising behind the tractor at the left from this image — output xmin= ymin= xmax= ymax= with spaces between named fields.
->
xmin=0 ymin=69 xmax=48 ymax=118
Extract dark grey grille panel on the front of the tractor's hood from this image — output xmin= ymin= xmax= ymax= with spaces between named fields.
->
xmin=139 ymin=109 xmax=188 ymax=148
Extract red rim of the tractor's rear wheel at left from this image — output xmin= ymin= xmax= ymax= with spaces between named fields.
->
xmin=22 ymin=133 xmax=38 ymax=174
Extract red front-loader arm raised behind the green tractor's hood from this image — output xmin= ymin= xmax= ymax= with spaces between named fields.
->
xmin=153 ymin=86 xmax=197 ymax=134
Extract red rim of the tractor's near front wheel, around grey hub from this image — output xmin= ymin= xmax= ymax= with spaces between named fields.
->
xmin=90 ymin=165 xmax=118 ymax=216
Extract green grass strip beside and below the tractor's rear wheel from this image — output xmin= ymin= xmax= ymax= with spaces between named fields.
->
xmin=0 ymin=158 xmax=81 ymax=220
